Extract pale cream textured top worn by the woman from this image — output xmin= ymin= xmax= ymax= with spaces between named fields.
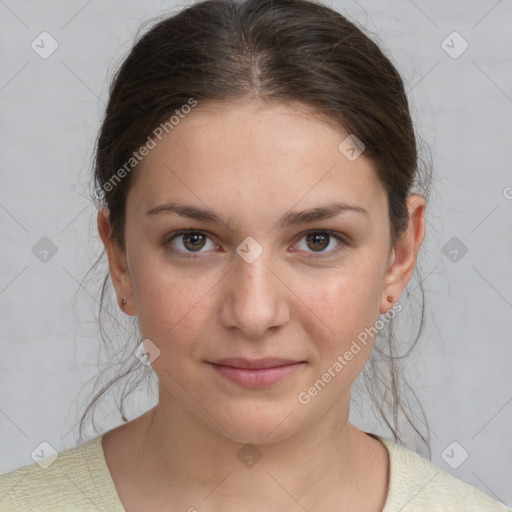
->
xmin=0 ymin=435 xmax=511 ymax=512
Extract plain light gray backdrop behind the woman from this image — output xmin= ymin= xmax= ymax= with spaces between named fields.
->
xmin=0 ymin=0 xmax=512 ymax=505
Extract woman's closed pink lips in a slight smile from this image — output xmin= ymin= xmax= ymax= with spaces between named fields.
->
xmin=209 ymin=358 xmax=305 ymax=389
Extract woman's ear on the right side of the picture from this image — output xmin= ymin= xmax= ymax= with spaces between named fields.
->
xmin=380 ymin=194 xmax=426 ymax=314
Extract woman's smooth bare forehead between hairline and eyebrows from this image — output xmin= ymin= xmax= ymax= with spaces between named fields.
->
xmin=128 ymin=102 xmax=386 ymax=222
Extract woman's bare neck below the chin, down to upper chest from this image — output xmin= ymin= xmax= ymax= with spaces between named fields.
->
xmin=131 ymin=386 xmax=387 ymax=512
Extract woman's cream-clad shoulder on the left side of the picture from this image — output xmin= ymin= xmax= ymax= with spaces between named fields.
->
xmin=0 ymin=435 xmax=124 ymax=512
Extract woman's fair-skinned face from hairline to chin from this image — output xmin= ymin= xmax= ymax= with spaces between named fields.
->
xmin=99 ymin=99 xmax=422 ymax=443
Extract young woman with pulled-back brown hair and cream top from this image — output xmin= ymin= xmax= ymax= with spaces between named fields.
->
xmin=0 ymin=0 xmax=506 ymax=512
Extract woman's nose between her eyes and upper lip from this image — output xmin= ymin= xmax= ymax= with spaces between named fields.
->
xmin=221 ymin=252 xmax=290 ymax=340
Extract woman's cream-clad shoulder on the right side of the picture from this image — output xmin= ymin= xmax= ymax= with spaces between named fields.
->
xmin=375 ymin=436 xmax=510 ymax=512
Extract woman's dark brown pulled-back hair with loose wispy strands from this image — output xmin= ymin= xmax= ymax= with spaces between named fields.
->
xmin=80 ymin=0 xmax=431 ymax=456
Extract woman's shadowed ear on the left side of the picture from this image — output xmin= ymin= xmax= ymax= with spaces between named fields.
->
xmin=98 ymin=208 xmax=137 ymax=316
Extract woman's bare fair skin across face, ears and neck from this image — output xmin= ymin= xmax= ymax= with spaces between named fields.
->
xmin=98 ymin=101 xmax=425 ymax=512
